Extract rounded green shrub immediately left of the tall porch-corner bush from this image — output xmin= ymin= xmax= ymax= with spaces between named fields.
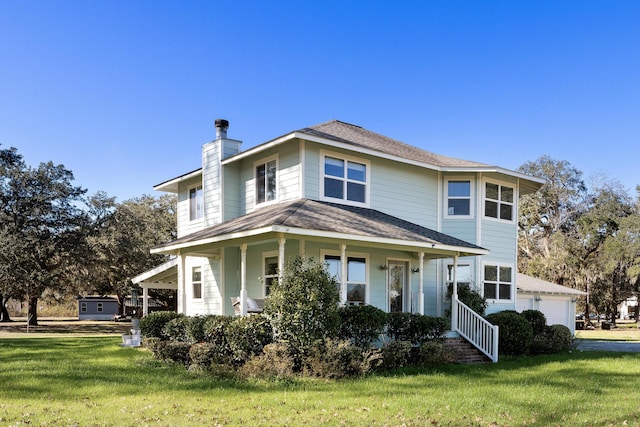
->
xmin=226 ymin=314 xmax=273 ymax=365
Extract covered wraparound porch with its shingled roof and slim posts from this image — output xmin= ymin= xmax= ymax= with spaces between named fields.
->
xmin=149 ymin=199 xmax=488 ymax=315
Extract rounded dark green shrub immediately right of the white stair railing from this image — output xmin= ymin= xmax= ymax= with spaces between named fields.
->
xmin=486 ymin=310 xmax=533 ymax=356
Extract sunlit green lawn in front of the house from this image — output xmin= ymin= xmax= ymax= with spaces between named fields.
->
xmin=0 ymin=337 xmax=640 ymax=426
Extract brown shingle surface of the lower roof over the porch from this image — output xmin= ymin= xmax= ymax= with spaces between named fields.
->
xmin=154 ymin=199 xmax=486 ymax=253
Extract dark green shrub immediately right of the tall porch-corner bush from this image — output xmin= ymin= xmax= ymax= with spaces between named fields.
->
xmin=338 ymin=305 xmax=387 ymax=349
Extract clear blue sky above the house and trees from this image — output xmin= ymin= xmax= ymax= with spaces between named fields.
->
xmin=0 ymin=0 xmax=640 ymax=201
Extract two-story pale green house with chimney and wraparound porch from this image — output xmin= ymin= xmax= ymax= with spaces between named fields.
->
xmin=134 ymin=120 xmax=544 ymax=362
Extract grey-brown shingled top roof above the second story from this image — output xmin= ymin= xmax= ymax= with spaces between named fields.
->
xmin=298 ymin=120 xmax=489 ymax=167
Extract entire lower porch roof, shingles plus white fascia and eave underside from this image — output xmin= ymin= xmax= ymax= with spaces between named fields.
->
xmin=152 ymin=199 xmax=489 ymax=258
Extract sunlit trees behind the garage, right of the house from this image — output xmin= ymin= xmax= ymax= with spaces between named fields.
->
xmin=518 ymin=156 xmax=640 ymax=323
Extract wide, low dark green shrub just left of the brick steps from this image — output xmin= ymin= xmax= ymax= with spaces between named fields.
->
xmin=387 ymin=313 xmax=446 ymax=345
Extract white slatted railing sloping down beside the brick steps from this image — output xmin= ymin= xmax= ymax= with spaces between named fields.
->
xmin=451 ymin=296 xmax=498 ymax=363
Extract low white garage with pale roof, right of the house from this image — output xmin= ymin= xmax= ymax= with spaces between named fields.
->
xmin=516 ymin=273 xmax=587 ymax=335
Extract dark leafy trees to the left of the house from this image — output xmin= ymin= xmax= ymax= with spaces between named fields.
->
xmin=0 ymin=148 xmax=176 ymax=325
